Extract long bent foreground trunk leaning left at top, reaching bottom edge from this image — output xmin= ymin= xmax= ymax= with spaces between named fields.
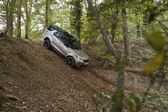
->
xmin=87 ymin=0 xmax=125 ymax=112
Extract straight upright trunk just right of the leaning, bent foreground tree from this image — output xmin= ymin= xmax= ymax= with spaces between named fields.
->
xmin=121 ymin=0 xmax=130 ymax=64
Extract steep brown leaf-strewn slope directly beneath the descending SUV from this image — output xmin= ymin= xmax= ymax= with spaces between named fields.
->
xmin=0 ymin=39 xmax=116 ymax=112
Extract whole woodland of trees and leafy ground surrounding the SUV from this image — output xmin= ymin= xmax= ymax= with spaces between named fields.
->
xmin=0 ymin=0 xmax=168 ymax=112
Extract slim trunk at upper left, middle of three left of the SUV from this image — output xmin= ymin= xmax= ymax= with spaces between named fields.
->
xmin=17 ymin=0 xmax=22 ymax=39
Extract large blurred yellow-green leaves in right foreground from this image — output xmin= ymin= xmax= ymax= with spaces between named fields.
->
xmin=143 ymin=31 xmax=166 ymax=73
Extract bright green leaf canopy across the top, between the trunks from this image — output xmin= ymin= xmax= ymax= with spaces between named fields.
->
xmin=0 ymin=0 xmax=168 ymax=41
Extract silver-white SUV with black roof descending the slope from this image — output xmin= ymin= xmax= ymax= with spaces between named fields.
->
xmin=43 ymin=25 xmax=89 ymax=67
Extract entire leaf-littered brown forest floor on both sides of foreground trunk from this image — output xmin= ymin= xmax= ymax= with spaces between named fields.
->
xmin=0 ymin=38 xmax=168 ymax=112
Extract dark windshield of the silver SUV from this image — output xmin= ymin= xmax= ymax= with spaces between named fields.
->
xmin=61 ymin=33 xmax=81 ymax=50
